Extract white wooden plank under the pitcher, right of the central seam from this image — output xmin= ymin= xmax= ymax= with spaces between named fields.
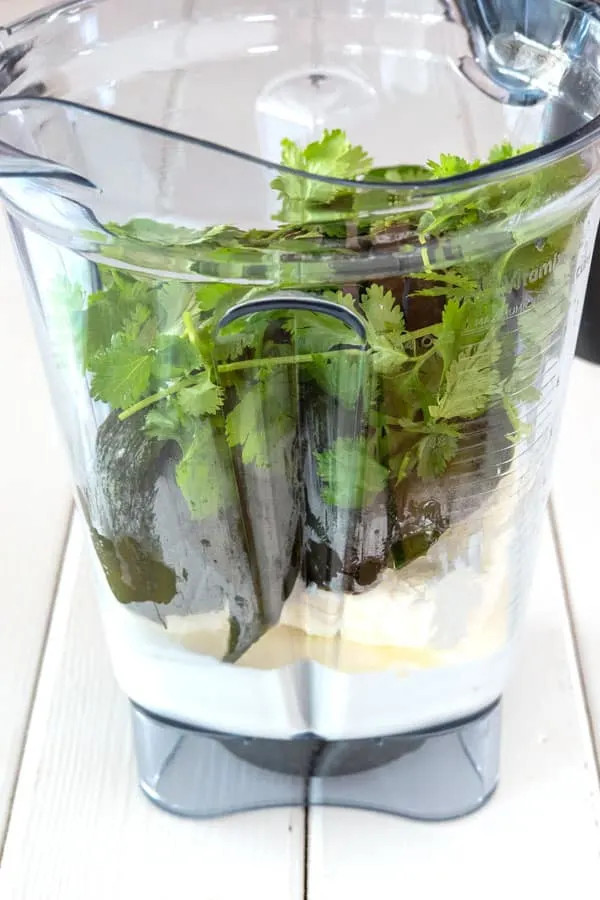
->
xmin=308 ymin=526 xmax=600 ymax=900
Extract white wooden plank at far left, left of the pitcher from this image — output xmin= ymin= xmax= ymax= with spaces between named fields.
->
xmin=0 ymin=216 xmax=71 ymax=851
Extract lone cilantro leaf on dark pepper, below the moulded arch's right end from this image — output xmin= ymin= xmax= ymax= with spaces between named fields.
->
xmin=317 ymin=438 xmax=388 ymax=509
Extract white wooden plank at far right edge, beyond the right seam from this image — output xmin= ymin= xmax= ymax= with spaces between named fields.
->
xmin=552 ymin=360 xmax=600 ymax=763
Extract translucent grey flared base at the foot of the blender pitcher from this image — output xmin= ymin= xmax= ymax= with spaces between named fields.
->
xmin=133 ymin=702 xmax=500 ymax=820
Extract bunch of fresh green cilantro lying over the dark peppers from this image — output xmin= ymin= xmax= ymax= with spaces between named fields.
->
xmin=67 ymin=130 xmax=585 ymax=552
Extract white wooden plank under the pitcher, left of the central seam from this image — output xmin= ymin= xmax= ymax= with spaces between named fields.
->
xmin=0 ymin=523 xmax=304 ymax=900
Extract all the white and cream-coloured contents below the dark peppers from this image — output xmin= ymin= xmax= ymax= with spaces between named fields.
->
xmin=96 ymin=478 xmax=515 ymax=740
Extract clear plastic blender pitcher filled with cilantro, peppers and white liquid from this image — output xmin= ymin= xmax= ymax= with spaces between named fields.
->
xmin=0 ymin=0 xmax=600 ymax=819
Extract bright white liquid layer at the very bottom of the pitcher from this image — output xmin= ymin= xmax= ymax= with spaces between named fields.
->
xmin=102 ymin=596 xmax=509 ymax=740
